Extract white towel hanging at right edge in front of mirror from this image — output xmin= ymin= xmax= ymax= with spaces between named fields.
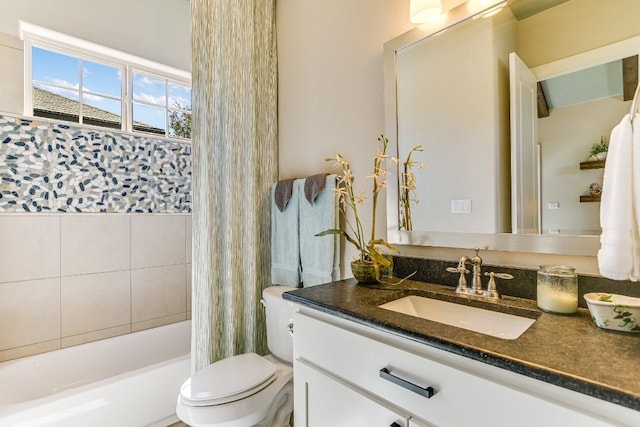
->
xmin=598 ymin=115 xmax=640 ymax=281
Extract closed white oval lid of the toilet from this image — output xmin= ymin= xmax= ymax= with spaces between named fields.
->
xmin=180 ymin=353 xmax=277 ymax=406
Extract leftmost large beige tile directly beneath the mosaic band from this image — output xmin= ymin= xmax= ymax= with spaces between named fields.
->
xmin=0 ymin=214 xmax=60 ymax=283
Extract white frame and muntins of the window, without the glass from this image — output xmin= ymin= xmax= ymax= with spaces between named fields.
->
xmin=20 ymin=22 xmax=192 ymax=141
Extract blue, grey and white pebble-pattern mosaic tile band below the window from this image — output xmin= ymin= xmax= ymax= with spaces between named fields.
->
xmin=0 ymin=116 xmax=191 ymax=213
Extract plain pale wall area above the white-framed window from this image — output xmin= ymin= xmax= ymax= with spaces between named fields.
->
xmin=0 ymin=0 xmax=191 ymax=71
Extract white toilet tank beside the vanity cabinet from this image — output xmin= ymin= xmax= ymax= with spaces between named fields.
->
xmin=262 ymin=286 xmax=295 ymax=362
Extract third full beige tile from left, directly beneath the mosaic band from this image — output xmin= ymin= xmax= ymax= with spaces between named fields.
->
xmin=131 ymin=215 xmax=186 ymax=269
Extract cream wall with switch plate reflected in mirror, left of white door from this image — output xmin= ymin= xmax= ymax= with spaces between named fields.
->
xmin=396 ymin=13 xmax=516 ymax=233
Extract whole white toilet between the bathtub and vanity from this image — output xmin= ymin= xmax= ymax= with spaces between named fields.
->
xmin=176 ymin=286 xmax=293 ymax=427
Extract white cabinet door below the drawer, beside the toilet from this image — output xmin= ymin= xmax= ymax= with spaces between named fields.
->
xmin=293 ymin=361 xmax=410 ymax=427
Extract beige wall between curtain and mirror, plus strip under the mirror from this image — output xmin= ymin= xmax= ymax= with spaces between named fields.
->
xmin=278 ymin=0 xmax=598 ymax=275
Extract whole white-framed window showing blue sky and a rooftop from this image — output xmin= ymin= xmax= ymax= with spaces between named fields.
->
xmin=23 ymin=26 xmax=191 ymax=139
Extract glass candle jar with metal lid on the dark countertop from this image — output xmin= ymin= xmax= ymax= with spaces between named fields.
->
xmin=537 ymin=265 xmax=578 ymax=314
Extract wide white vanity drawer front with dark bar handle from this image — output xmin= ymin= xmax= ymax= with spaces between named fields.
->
xmin=294 ymin=312 xmax=610 ymax=426
